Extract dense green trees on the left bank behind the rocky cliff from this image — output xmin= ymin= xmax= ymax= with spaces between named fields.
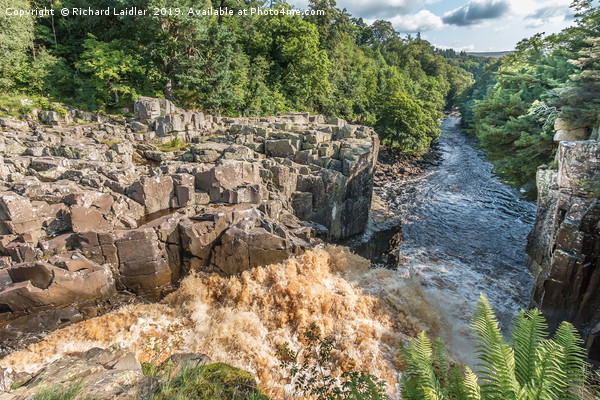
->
xmin=0 ymin=0 xmax=479 ymax=153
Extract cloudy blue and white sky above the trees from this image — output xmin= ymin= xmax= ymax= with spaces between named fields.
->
xmin=290 ymin=0 xmax=573 ymax=52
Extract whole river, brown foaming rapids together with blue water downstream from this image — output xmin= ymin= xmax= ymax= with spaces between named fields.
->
xmin=0 ymin=118 xmax=535 ymax=399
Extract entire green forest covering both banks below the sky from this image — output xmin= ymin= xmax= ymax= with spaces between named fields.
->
xmin=0 ymin=0 xmax=600 ymax=185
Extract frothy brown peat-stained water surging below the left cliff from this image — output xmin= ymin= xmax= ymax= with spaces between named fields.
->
xmin=0 ymin=246 xmax=438 ymax=398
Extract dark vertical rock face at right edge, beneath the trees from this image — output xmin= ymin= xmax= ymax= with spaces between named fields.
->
xmin=527 ymin=141 xmax=600 ymax=360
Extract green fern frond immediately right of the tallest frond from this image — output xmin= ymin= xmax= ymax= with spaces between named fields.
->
xmin=511 ymin=309 xmax=548 ymax=385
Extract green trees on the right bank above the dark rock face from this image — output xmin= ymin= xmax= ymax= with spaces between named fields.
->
xmin=460 ymin=0 xmax=600 ymax=185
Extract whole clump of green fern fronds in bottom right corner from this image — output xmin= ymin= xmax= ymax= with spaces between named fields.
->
xmin=402 ymin=296 xmax=593 ymax=400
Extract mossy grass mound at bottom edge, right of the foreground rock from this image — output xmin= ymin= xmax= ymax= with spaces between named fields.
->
xmin=143 ymin=363 xmax=268 ymax=400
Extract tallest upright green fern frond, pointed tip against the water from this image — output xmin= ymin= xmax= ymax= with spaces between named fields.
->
xmin=471 ymin=295 xmax=520 ymax=400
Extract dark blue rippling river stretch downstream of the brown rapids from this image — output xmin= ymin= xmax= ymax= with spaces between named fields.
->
xmin=378 ymin=118 xmax=535 ymax=361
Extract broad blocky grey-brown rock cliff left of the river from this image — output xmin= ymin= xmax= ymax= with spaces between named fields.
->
xmin=0 ymin=98 xmax=379 ymax=354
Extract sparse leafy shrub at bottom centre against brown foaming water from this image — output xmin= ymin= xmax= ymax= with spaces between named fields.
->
xmin=277 ymin=323 xmax=388 ymax=400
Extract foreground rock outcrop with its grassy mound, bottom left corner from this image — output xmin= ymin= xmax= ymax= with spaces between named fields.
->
xmin=0 ymin=343 xmax=265 ymax=400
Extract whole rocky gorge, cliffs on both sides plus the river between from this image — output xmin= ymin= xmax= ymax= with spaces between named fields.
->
xmin=0 ymin=98 xmax=600 ymax=399
